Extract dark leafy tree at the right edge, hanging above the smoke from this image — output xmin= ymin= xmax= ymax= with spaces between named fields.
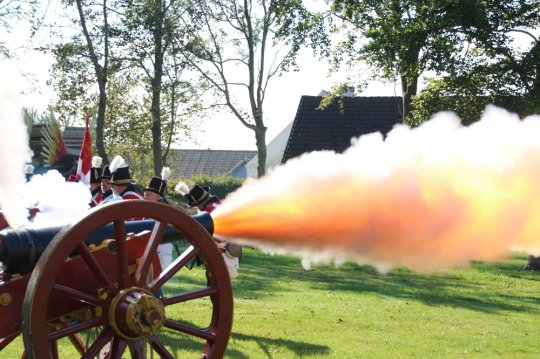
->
xmin=414 ymin=1 xmax=540 ymax=124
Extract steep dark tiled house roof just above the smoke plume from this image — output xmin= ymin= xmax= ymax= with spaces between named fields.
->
xmin=282 ymin=96 xmax=403 ymax=163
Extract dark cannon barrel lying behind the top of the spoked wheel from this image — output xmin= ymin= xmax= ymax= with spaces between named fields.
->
xmin=0 ymin=212 xmax=214 ymax=274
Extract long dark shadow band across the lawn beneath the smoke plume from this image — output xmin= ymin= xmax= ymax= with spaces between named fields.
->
xmin=233 ymin=250 xmax=540 ymax=313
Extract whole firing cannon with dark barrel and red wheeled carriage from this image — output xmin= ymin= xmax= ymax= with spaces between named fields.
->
xmin=0 ymin=200 xmax=233 ymax=359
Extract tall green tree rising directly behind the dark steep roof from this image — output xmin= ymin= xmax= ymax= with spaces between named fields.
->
xmin=332 ymin=0 xmax=490 ymax=118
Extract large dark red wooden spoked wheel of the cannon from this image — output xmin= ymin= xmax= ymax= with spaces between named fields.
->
xmin=22 ymin=200 xmax=233 ymax=359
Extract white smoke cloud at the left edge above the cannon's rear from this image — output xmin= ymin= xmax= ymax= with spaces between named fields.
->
xmin=0 ymin=61 xmax=91 ymax=228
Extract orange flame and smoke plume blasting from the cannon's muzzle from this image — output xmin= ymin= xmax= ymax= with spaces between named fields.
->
xmin=212 ymin=107 xmax=540 ymax=270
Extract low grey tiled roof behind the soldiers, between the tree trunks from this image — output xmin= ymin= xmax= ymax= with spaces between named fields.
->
xmin=170 ymin=149 xmax=257 ymax=177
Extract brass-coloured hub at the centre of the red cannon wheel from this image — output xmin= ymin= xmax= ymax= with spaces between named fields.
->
xmin=109 ymin=287 xmax=165 ymax=339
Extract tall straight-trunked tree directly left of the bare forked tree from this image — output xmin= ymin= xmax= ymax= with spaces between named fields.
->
xmin=117 ymin=0 xmax=200 ymax=176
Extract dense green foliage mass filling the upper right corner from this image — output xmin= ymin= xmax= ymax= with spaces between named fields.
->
xmin=332 ymin=0 xmax=540 ymax=122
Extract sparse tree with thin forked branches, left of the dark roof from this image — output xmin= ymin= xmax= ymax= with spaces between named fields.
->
xmin=179 ymin=0 xmax=324 ymax=177
